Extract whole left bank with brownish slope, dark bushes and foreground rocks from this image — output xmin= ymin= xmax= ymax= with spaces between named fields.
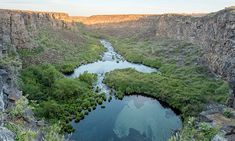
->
xmin=0 ymin=22 xmax=105 ymax=141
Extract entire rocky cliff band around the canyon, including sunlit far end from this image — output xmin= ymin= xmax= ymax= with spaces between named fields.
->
xmin=0 ymin=7 xmax=235 ymax=80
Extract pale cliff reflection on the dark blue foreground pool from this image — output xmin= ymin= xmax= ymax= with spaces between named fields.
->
xmin=113 ymin=97 xmax=180 ymax=141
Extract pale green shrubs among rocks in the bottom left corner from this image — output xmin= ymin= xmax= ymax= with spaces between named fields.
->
xmin=4 ymin=96 xmax=63 ymax=141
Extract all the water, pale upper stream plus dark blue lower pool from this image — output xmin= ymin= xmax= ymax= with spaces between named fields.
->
xmin=68 ymin=40 xmax=182 ymax=141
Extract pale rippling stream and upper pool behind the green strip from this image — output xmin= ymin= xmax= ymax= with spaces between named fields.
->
xmin=70 ymin=40 xmax=158 ymax=95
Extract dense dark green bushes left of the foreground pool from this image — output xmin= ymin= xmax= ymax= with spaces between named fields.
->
xmin=21 ymin=64 xmax=106 ymax=132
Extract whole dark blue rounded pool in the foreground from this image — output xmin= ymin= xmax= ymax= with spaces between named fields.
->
xmin=71 ymin=96 xmax=181 ymax=141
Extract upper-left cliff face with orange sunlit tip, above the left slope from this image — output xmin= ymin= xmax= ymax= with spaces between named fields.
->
xmin=0 ymin=10 xmax=75 ymax=54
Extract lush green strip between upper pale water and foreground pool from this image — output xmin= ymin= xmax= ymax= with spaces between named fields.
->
xmin=105 ymin=69 xmax=227 ymax=117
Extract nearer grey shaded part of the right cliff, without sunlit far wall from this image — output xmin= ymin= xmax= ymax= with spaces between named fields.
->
xmin=155 ymin=9 xmax=235 ymax=80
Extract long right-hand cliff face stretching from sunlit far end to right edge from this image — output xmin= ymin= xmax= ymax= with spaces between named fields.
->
xmin=87 ymin=7 xmax=235 ymax=80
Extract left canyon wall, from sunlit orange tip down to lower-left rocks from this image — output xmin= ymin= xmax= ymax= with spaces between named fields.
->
xmin=0 ymin=10 xmax=75 ymax=118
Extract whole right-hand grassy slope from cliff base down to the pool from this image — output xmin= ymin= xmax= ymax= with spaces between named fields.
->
xmin=105 ymin=38 xmax=228 ymax=117
